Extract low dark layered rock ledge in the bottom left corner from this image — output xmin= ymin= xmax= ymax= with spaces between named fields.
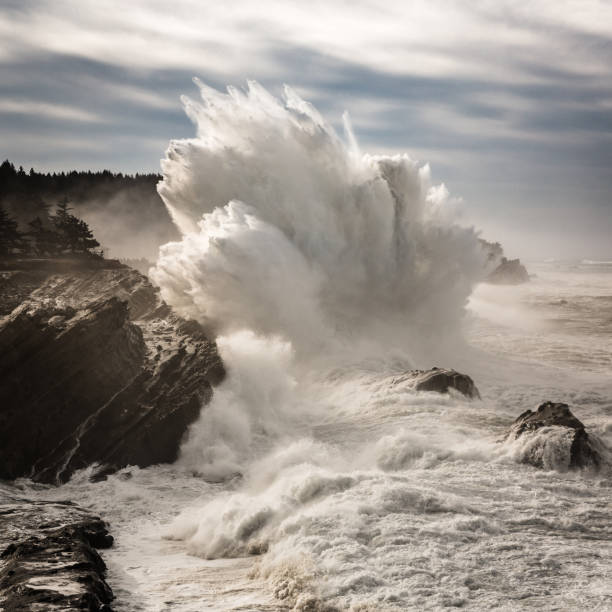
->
xmin=0 ymin=499 xmax=113 ymax=612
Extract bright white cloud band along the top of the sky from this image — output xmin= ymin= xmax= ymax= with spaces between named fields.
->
xmin=0 ymin=0 xmax=612 ymax=83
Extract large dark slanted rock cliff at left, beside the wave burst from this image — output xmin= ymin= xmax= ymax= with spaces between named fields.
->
xmin=0 ymin=266 xmax=224 ymax=482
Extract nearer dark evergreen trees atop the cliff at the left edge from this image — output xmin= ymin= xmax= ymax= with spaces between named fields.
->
xmin=0 ymin=198 xmax=103 ymax=257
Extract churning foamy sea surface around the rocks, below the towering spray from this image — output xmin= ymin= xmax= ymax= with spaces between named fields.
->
xmin=16 ymin=263 xmax=612 ymax=612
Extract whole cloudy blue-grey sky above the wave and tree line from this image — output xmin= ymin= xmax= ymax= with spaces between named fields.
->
xmin=0 ymin=0 xmax=612 ymax=259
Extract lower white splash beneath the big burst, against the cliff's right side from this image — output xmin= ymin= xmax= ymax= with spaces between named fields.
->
xmin=181 ymin=331 xmax=312 ymax=480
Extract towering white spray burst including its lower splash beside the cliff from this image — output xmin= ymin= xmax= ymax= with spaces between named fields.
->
xmin=152 ymin=77 xmax=483 ymax=478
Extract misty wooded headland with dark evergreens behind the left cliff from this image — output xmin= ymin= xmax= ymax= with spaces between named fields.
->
xmin=0 ymin=160 xmax=177 ymax=257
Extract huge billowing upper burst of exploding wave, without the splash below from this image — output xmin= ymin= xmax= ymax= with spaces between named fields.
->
xmin=154 ymin=82 xmax=482 ymax=354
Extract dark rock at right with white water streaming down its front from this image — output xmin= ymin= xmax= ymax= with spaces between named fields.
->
xmin=508 ymin=402 xmax=602 ymax=469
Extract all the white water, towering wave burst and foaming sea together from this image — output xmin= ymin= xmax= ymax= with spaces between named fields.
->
xmin=16 ymin=84 xmax=612 ymax=612
